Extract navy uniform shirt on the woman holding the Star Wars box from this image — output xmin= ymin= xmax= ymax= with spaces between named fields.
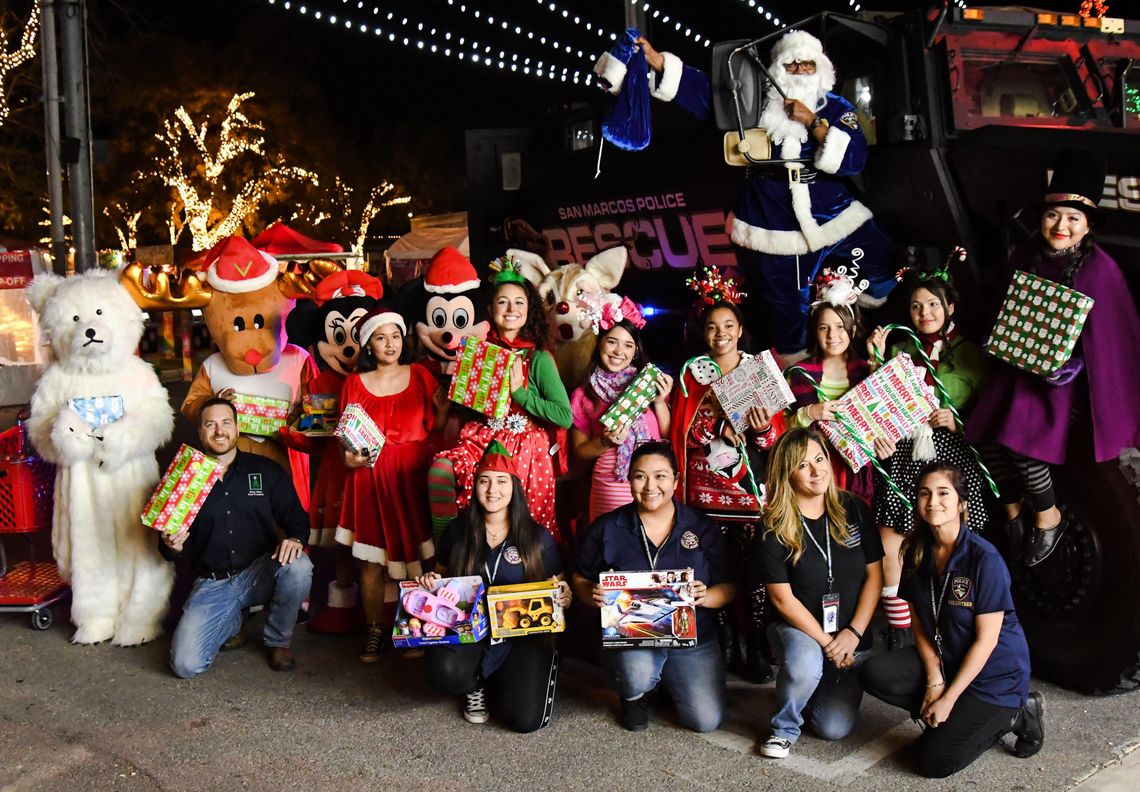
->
xmin=578 ymin=498 xmax=733 ymax=644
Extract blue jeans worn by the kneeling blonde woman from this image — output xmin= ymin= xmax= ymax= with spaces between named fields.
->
xmin=768 ymin=622 xmax=866 ymax=743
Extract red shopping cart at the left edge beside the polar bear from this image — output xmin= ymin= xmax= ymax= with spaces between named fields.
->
xmin=0 ymin=424 xmax=70 ymax=630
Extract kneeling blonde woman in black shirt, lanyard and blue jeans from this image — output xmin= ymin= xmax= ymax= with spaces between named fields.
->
xmin=750 ymin=428 xmax=882 ymax=759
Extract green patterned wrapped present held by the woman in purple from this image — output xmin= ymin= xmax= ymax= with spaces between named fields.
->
xmin=986 ymin=270 xmax=1093 ymax=377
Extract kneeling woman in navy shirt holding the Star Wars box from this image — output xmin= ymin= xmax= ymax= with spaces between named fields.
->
xmin=573 ymin=441 xmax=736 ymax=732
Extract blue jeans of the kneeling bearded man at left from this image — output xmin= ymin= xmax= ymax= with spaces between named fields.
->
xmin=170 ymin=554 xmax=312 ymax=679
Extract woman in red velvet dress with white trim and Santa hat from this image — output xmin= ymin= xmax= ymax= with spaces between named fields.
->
xmin=336 ymin=305 xmax=447 ymax=663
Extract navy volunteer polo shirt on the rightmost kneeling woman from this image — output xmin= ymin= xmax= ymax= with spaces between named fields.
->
xmin=898 ymin=525 xmax=1029 ymax=707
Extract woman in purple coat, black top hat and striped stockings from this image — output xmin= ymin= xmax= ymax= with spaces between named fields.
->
xmin=967 ymin=150 xmax=1140 ymax=566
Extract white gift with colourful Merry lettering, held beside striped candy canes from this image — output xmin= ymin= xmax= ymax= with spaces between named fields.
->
xmin=817 ymin=352 xmax=938 ymax=471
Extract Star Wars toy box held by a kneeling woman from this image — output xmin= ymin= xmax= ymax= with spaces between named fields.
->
xmin=601 ymin=569 xmax=697 ymax=648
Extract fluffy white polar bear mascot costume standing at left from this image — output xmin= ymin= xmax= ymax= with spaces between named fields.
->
xmin=27 ymin=271 xmax=174 ymax=646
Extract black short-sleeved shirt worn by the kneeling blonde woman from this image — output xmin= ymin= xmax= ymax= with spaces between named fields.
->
xmin=749 ymin=493 xmax=884 ymax=648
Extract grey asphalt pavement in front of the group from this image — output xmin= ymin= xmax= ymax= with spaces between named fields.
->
xmin=0 ymin=613 xmax=1140 ymax=792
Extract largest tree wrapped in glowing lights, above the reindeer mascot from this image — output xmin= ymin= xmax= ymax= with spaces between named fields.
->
xmin=155 ymin=92 xmax=318 ymax=251
